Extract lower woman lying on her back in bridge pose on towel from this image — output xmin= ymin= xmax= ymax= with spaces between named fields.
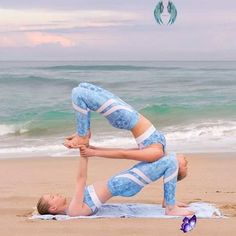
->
xmin=37 ymin=146 xmax=194 ymax=216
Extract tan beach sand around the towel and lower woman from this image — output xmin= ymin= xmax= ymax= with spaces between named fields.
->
xmin=0 ymin=153 xmax=236 ymax=236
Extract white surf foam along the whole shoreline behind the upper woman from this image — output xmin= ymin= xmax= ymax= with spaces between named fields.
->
xmin=0 ymin=121 xmax=236 ymax=158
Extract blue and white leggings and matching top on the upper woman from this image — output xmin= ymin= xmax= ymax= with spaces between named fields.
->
xmin=72 ymin=83 xmax=166 ymax=148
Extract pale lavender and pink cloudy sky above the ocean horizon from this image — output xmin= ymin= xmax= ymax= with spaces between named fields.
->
xmin=0 ymin=0 xmax=236 ymax=60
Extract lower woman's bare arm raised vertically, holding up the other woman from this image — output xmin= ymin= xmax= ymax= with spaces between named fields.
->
xmin=67 ymin=147 xmax=88 ymax=216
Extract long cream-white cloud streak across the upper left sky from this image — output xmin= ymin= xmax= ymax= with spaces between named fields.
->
xmin=0 ymin=9 xmax=139 ymax=33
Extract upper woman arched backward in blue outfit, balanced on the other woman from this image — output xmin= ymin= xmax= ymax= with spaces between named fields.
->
xmin=64 ymin=83 xmax=166 ymax=162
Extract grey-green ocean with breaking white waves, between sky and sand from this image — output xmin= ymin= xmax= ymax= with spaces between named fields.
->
xmin=0 ymin=61 xmax=236 ymax=158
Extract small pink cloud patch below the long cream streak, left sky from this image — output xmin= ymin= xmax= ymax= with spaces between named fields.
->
xmin=26 ymin=32 xmax=75 ymax=47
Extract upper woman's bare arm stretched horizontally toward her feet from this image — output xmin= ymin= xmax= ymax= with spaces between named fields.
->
xmin=81 ymin=145 xmax=164 ymax=162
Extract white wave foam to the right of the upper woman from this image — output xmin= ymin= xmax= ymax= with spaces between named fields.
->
xmin=164 ymin=120 xmax=236 ymax=152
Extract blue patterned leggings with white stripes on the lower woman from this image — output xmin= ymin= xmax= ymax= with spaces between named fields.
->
xmin=108 ymin=154 xmax=179 ymax=205
